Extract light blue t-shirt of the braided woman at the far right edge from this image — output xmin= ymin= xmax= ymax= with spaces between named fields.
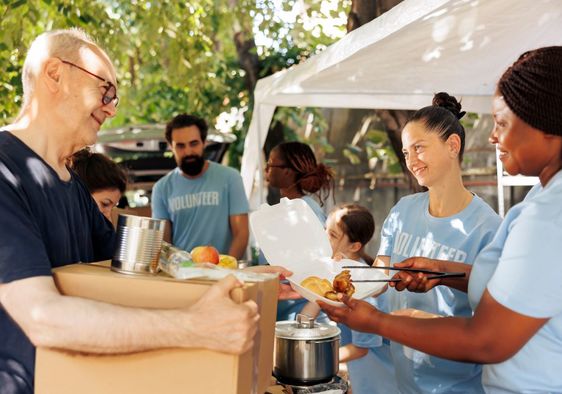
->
xmin=468 ymin=171 xmax=562 ymax=393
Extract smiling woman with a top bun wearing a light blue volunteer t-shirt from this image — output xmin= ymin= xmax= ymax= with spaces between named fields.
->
xmin=328 ymin=92 xmax=501 ymax=393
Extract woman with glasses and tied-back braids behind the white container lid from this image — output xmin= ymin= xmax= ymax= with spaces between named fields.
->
xmin=265 ymin=142 xmax=334 ymax=224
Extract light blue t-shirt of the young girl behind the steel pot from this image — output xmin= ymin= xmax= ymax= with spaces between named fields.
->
xmin=347 ymin=293 xmax=398 ymax=394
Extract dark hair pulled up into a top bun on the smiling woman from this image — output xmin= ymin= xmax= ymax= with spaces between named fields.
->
xmin=408 ymin=92 xmax=466 ymax=163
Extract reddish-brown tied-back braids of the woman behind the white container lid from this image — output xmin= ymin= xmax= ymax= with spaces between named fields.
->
xmin=274 ymin=142 xmax=334 ymax=205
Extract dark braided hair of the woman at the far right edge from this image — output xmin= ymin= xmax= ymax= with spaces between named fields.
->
xmin=497 ymin=46 xmax=562 ymax=136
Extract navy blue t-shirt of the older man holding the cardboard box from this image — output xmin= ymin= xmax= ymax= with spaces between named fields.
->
xmin=0 ymin=131 xmax=115 ymax=393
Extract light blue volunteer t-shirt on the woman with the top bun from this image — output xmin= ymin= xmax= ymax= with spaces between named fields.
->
xmin=378 ymin=192 xmax=501 ymax=393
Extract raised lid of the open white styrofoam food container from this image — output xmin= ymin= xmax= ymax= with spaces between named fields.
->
xmin=250 ymin=198 xmax=332 ymax=272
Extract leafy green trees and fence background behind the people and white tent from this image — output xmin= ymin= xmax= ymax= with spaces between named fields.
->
xmin=0 ymin=0 xmax=526 ymax=254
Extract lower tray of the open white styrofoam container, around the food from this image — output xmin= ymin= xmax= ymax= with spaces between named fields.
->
xmin=287 ymin=258 xmax=389 ymax=306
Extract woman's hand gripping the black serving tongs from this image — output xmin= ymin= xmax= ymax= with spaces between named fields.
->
xmin=389 ymin=257 xmax=441 ymax=293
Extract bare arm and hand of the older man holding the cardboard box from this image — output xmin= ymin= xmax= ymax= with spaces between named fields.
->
xmin=0 ymin=276 xmax=259 ymax=354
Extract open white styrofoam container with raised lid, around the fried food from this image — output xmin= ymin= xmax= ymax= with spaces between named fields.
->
xmin=250 ymin=198 xmax=388 ymax=306
